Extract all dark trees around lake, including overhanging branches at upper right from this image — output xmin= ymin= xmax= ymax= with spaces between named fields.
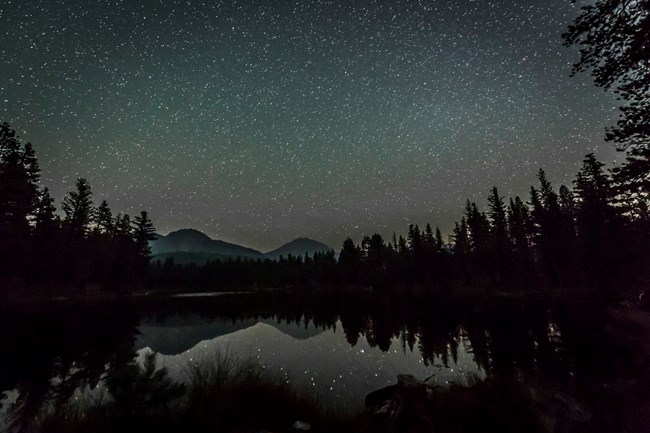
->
xmin=0 ymin=0 xmax=650 ymax=296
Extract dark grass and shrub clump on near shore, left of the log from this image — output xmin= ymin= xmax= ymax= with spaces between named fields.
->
xmin=37 ymin=352 xmax=350 ymax=433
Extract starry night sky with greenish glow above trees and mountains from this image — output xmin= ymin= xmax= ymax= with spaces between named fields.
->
xmin=0 ymin=0 xmax=621 ymax=251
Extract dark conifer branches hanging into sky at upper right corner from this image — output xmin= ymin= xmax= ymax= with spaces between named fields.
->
xmin=563 ymin=0 xmax=650 ymax=224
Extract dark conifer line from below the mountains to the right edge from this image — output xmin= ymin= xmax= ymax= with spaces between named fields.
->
xmin=150 ymin=154 xmax=650 ymax=295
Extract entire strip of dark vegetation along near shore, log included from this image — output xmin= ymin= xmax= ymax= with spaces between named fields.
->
xmin=32 ymin=354 xmax=560 ymax=433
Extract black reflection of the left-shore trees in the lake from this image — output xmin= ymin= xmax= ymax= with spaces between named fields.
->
xmin=0 ymin=305 xmax=138 ymax=432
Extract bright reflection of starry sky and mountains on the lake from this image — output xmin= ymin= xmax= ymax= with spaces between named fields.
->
xmin=136 ymin=318 xmax=485 ymax=411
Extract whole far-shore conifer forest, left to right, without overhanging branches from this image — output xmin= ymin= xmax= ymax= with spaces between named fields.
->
xmin=0 ymin=123 xmax=650 ymax=296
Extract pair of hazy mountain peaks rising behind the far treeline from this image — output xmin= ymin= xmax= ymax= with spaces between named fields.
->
xmin=149 ymin=229 xmax=331 ymax=265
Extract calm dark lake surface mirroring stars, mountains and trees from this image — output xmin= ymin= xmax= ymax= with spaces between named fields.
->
xmin=0 ymin=295 xmax=648 ymax=431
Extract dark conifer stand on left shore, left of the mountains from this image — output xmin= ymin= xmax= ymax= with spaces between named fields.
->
xmin=0 ymin=123 xmax=155 ymax=292
